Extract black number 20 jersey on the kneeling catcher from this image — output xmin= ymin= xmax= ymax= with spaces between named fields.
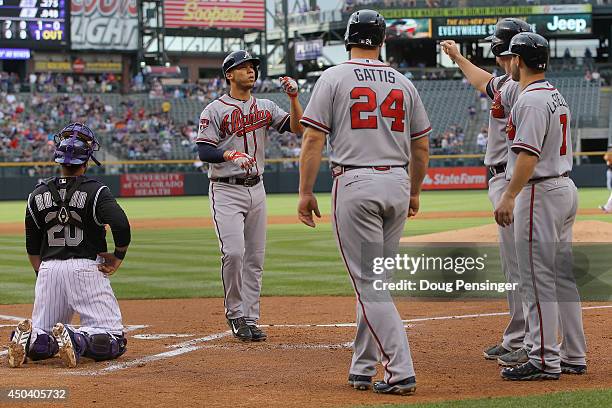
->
xmin=25 ymin=176 xmax=130 ymax=261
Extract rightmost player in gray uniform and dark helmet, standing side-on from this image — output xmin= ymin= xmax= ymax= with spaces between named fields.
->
xmin=495 ymin=33 xmax=586 ymax=380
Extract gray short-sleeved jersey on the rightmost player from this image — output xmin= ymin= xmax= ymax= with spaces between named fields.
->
xmin=506 ymin=80 xmax=573 ymax=180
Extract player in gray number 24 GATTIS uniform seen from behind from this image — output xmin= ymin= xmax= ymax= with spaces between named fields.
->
xmin=298 ymin=10 xmax=431 ymax=395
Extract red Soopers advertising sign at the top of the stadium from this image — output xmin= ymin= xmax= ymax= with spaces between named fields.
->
xmin=164 ymin=0 xmax=266 ymax=30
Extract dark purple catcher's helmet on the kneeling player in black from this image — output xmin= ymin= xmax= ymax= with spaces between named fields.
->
xmin=53 ymin=123 xmax=100 ymax=166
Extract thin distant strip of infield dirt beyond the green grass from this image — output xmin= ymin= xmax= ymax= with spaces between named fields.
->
xmin=0 ymin=208 xmax=601 ymax=235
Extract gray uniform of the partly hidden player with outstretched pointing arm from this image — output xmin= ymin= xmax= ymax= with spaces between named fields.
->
xmin=484 ymin=75 xmax=530 ymax=350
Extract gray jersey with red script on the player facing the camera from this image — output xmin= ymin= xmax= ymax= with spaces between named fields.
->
xmin=196 ymin=95 xmax=289 ymax=178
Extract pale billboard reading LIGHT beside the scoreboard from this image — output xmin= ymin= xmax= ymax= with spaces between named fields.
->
xmin=70 ymin=0 xmax=138 ymax=51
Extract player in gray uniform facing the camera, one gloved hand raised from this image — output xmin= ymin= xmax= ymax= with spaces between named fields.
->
xmin=196 ymin=51 xmax=303 ymax=341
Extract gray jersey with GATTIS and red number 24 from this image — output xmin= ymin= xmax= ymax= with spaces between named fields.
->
xmin=301 ymin=59 xmax=431 ymax=166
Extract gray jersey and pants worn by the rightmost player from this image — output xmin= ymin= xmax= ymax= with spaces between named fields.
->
xmin=506 ymin=80 xmax=586 ymax=373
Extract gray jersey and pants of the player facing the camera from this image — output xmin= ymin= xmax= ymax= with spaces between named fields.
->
xmin=196 ymin=95 xmax=289 ymax=323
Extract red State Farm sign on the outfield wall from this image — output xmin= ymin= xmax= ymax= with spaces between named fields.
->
xmin=423 ymin=167 xmax=487 ymax=190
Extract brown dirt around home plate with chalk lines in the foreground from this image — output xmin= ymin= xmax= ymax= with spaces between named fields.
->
xmin=0 ymin=297 xmax=612 ymax=407
